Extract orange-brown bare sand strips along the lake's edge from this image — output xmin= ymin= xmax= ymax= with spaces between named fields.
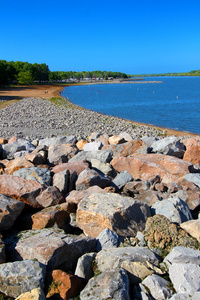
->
xmin=0 ymin=81 xmax=199 ymax=136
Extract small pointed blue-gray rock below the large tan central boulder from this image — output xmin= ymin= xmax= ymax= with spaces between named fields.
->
xmin=97 ymin=228 xmax=119 ymax=252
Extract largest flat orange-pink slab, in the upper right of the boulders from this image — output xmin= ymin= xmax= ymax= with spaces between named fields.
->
xmin=111 ymin=154 xmax=193 ymax=180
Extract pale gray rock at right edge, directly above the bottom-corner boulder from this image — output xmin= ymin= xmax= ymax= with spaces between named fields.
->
xmin=164 ymin=246 xmax=200 ymax=266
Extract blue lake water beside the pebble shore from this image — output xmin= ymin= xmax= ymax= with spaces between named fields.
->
xmin=62 ymin=77 xmax=200 ymax=134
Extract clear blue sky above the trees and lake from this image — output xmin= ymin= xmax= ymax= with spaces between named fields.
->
xmin=0 ymin=0 xmax=200 ymax=74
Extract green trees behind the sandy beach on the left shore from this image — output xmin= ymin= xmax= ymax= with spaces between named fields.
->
xmin=0 ymin=60 xmax=129 ymax=85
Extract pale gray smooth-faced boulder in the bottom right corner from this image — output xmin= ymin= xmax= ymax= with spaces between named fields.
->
xmin=169 ymin=263 xmax=200 ymax=294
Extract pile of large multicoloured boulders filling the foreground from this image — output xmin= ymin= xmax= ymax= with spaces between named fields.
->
xmin=0 ymin=127 xmax=200 ymax=300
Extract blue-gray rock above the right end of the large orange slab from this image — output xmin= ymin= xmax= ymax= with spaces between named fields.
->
xmin=151 ymin=136 xmax=185 ymax=158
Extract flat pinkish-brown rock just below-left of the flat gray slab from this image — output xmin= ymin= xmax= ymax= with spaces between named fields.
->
xmin=52 ymin=160 xmax=90 ymax=175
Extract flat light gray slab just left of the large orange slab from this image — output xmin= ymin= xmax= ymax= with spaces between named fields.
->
xmin=69 ymin=150 xmax=113 ymax=163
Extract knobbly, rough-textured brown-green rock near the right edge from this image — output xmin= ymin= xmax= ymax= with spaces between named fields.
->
xmin=143 ymin=215 xmax=199 ymax=256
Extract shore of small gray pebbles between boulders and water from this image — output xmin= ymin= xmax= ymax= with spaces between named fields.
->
xmin=0 ymin=98 xmax=173 ymax=139
